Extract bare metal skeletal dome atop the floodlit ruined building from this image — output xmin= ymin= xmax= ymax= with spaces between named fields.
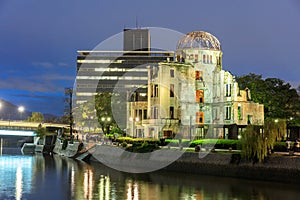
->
xmin=176 ymin=31 xmax=221 ymax=51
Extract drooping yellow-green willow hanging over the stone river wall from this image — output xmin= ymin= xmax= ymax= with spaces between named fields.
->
xmin=241 ymin=119 xmax=286 ymax=162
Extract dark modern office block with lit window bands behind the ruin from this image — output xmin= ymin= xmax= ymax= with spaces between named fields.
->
xmin=74 ymin=29 xmax=175 ymax=129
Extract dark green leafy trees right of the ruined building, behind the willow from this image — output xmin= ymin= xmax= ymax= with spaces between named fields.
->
xmin=237 ymin=73 xmax=300 ymax=124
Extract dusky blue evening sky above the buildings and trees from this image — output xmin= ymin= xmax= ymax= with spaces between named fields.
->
xmin=0 ymin=0 xmax=300 ymax=115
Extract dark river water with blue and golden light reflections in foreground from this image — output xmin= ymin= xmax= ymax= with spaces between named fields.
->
xmin=0 ymin=150 xmax=300 ymax=200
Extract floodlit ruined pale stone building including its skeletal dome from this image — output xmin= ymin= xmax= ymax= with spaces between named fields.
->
xmin=127 ymin=31 xmax=264 ymax=139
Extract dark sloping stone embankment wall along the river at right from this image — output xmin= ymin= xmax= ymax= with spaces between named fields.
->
xmin=165 ymin=152 xmax=300 ymax=183
